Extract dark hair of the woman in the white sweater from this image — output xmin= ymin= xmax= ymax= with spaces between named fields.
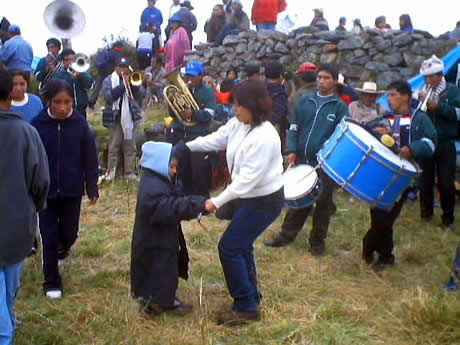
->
xmin=233 ymin=80 xmax=272 ymax=127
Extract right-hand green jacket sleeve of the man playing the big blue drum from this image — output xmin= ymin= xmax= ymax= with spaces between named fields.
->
xmin=409 ymin=110 xmax=437 ymax=162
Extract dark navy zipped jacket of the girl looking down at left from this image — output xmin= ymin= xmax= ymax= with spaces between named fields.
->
xmin=31 ymin=110 xmax=99 ymax=199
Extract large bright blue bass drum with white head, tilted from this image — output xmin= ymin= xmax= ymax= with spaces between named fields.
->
xmin=318 ymin=119 xmax=419 ymax=210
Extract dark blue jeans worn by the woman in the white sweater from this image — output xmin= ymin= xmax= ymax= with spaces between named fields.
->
xmin=219 ymin=194 xmax=282 ymax=312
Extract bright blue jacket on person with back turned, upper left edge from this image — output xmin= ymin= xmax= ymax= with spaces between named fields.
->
xmin=0 ymin=36 xmax=34 ymax=72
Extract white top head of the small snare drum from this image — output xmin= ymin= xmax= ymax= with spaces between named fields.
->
xmin=283 ymin=164 xmax=318 ymax=200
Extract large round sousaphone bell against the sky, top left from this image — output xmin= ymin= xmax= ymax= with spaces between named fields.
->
xmin=43 ymin=0 xmax=86 ymax=39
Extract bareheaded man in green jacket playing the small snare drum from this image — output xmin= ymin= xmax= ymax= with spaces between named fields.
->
xmin=265 ymin=64 xmax=348 ymax=256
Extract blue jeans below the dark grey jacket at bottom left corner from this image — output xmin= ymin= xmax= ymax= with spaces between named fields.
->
xmin=0 ymin=261 xmax=23 ymax=345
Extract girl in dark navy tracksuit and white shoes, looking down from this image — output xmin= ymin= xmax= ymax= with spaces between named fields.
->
xmin=32 ymin=80 xmax=99 ymax=298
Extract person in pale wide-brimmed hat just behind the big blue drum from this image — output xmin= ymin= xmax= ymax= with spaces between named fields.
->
xmin=348 ymin=81 xmax=387 ymax=123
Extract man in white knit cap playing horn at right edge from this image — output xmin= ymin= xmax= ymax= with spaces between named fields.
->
xmin=420 ymin=55 xmax=460 ymax=231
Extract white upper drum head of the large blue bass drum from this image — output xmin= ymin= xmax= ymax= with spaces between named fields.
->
xmin=347 ymin=122 xmax=417 ymax=173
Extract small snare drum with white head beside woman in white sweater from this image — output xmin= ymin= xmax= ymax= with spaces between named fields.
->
xmin=283 ymin=164 xmax=321 ymax=209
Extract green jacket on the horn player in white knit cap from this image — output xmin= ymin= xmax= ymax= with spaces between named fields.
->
xmin=427 ymin=84 xmax=460 ymax=145
